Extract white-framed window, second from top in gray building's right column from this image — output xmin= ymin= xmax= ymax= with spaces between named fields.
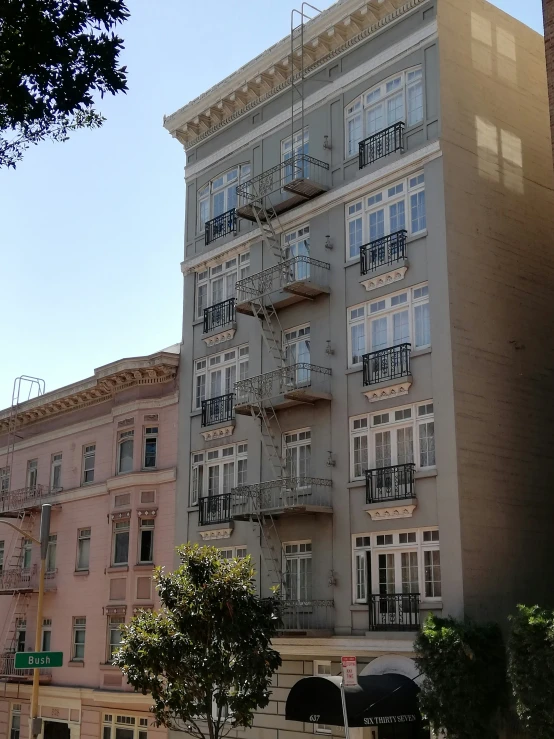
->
xmin=345 ymin=172 xmax=427 ymax=260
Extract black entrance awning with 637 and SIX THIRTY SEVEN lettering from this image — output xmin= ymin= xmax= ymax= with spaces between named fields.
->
xmin=285 ymin=673 xmax=419 ymax=726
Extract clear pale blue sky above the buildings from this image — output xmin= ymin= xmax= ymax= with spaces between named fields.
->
xmin=0 ymin=0 xmax=542 ymax=408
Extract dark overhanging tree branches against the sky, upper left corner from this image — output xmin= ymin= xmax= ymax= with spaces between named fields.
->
xmin=0 ymin=0 xmax=129 ymax=168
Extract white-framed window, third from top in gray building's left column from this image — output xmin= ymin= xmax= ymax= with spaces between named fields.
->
xmin=193 ymin=344 xmax=248 ymax=410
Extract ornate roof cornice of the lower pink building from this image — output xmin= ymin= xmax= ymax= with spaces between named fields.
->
xmin=0 ymin=351 xmax=179 ymax=433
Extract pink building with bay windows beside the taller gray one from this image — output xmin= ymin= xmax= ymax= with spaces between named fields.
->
xmin=0 ymin=345 xmax=179 ymax=739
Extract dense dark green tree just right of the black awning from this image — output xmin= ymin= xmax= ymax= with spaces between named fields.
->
xmin=415 ymin=615 xmax=506 ymax=739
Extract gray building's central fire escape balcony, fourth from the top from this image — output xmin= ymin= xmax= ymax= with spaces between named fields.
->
xmin=231 ymin=477 xmax=333 ymax=521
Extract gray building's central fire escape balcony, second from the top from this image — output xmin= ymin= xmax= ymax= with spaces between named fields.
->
xmin=237 ymin=255 xmax=330 ymax=316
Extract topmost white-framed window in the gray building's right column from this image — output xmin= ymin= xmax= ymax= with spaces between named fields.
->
xmin=345 ymin=67 xmax=423 ymax=157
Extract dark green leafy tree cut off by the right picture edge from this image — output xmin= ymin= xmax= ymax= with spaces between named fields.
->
xmin=508 ymin=605 xmax=554 ymax=739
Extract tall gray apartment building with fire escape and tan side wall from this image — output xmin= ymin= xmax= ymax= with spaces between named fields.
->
xmin=164 ymin=0 xmax=554 ymax=739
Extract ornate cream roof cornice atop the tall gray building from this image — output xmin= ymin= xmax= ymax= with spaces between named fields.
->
xmin=164 ymin=0 xmax=425 ymax=150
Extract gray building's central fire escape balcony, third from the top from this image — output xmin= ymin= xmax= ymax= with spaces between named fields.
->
xmin=235 ymin=362 xmax=331 ymax=416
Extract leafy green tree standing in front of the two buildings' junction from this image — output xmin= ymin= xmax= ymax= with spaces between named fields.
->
xmin=114 ymin=544 xmax=281 ymax=739
